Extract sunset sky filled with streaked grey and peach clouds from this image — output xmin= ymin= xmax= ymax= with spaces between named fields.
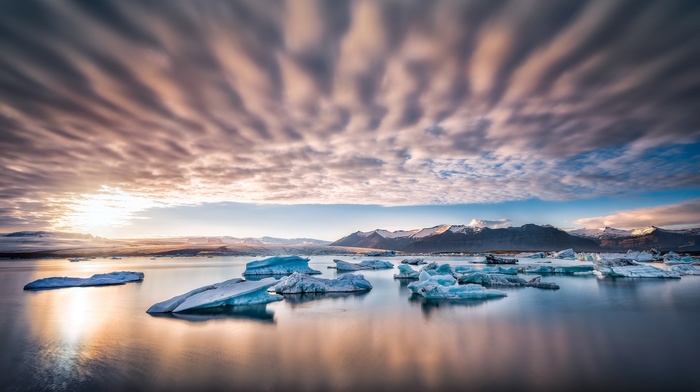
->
xmin=0 ymin=0 xmax=700 ymax=240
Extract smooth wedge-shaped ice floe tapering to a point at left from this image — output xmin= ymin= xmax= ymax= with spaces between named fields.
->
xmin=146 ymin=278 xmax=283 ymax=313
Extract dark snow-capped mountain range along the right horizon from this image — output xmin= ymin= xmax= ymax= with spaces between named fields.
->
xmin=331 ymin=224 xmax=700 ymax=252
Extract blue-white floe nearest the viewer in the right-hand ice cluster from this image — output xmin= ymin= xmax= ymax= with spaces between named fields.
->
xmin=407 ymin=271 xmax=508 ymax=299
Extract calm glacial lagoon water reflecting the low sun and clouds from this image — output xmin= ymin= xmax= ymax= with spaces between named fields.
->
xmin=0 ymin=256 xmax=700 ymax=391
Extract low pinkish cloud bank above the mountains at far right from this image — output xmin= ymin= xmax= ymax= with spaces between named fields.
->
xmin=574 ymin=199 xmax=700 ymax=229
